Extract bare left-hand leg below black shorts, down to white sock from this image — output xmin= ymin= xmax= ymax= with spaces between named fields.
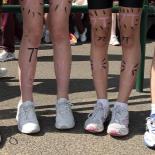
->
xmin=89 ymin=9 xmax=111 ymax=99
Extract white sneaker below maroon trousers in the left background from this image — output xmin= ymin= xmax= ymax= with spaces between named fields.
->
xmin=0 ymin=50 xmax=15 ymax=61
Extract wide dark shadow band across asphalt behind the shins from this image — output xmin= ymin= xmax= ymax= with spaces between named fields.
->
xmin=0 ymin=74 xmax=149 ymax=102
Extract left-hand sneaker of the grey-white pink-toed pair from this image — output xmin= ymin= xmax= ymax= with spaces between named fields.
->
xmin=84 ymin=101 xmax=109 ymax=133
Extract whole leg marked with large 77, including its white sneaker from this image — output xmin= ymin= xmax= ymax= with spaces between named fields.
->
xmin=16 ymin=0 xmax=43 ymax=134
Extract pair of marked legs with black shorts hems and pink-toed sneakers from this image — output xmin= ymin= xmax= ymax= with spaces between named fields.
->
xmin=85 ymin=0 xmax=142 ymax=136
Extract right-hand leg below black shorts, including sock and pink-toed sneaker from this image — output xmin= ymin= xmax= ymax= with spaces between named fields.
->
xmin=107 ymin=7 xmax=141 ymax=136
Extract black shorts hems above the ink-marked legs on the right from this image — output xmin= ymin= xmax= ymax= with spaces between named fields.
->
xmin=88 ymin=0 xmax=143 ymax=9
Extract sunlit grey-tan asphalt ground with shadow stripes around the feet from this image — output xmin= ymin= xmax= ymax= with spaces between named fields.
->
xmin=0 ymin=41 xmax=155 ymax=155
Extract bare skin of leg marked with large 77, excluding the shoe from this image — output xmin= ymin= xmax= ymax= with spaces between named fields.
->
xmin=19 ymin=0 xmax=43 ymax=102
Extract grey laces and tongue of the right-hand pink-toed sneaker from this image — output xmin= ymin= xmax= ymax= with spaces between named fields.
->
xmin=111 ymin=106 xmax=125 ymax=124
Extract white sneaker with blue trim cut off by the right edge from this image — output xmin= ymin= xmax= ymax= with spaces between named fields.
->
xmin=144 ymin=114 xmax=155 ymax=148
